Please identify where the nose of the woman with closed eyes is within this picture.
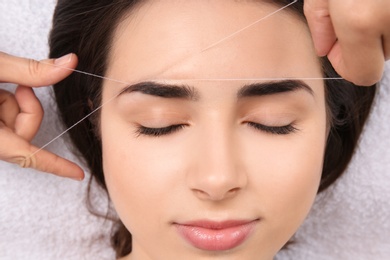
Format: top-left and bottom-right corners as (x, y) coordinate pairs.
(187, 128), (247, 201)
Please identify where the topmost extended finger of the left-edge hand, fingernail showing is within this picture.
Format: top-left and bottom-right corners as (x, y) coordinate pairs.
(0, 52), (77, 87)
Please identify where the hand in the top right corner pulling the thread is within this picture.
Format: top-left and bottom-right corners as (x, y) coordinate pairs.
(305, 0), (390, 86)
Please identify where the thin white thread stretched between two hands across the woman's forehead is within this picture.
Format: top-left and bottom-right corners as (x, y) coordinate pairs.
(30, 0), (343, 158)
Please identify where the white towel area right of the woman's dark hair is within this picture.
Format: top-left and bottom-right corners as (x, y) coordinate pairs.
(277, 62), (390, 260)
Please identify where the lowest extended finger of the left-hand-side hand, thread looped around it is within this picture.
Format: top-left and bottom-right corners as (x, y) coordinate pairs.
(0, 124), (84, 180)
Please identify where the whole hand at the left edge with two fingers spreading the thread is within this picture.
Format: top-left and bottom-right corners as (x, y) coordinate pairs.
(0, 52), (84, 180)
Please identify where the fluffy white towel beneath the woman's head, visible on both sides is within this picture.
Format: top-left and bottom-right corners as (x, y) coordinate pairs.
(0, 0), (390, 260)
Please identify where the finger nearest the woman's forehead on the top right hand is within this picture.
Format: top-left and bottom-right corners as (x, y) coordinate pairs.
(304, 0), (337, 56)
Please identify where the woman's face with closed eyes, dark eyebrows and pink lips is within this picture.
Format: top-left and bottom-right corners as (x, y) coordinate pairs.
(101, 0), (327, 260)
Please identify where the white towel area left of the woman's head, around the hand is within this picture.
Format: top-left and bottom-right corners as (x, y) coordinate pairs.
(0, 0), (115, 260)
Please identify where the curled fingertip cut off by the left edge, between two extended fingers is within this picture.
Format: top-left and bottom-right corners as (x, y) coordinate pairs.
(0, 89), (19, 129)
